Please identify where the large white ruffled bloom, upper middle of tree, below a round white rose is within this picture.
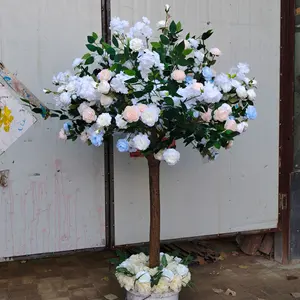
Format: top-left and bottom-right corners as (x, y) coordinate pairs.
(137, 49), (164, 81)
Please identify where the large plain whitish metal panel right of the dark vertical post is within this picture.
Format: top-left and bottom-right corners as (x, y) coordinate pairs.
(112, 0), (280, 245)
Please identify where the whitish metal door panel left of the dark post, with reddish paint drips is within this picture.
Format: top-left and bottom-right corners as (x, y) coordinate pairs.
(0, 0), (105, 257)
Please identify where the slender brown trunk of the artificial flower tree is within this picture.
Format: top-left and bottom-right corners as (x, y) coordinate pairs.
(147, 155), (160, 268)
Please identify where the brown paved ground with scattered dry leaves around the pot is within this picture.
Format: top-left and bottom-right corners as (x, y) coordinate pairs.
(0, 252), (300, 300)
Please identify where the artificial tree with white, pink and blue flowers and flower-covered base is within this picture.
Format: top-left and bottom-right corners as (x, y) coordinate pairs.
(26, 5), (257, 299)
